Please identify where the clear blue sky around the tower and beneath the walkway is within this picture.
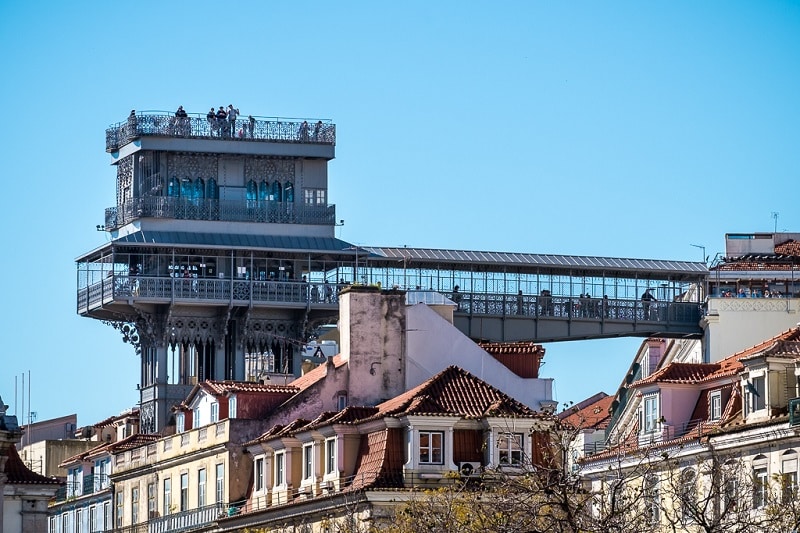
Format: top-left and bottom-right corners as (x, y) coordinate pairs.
(0, 0), (800, 424)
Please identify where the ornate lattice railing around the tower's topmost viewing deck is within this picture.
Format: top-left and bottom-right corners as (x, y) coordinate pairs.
(106, 112), (336, 152)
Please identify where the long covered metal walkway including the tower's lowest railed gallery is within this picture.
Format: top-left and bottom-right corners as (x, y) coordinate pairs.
(77, 239), (708, 342)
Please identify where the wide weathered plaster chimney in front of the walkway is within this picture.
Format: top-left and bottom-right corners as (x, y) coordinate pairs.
(339, 285), (406, 405)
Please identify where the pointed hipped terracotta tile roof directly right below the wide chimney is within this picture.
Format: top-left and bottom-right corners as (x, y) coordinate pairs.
(372, 366), (543, 418)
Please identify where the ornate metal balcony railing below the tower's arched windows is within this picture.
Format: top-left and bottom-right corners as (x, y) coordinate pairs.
(105, 196), (336, 230)
